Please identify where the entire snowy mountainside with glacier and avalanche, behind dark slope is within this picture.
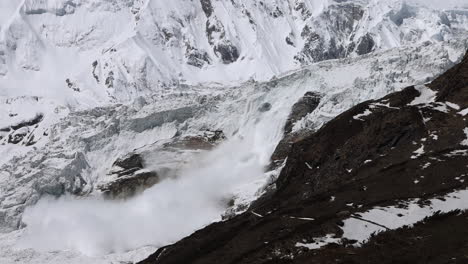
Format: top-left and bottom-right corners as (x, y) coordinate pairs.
(0, 0), (468, 263)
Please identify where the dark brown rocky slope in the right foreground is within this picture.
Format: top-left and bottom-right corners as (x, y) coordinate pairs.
(141, 50), (468, 264)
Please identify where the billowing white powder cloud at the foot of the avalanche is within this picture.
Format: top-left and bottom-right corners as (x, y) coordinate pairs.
(20, 136), (263, 256)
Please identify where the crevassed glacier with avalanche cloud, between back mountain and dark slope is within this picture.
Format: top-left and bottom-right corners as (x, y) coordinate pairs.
(0, 41), (464, 259)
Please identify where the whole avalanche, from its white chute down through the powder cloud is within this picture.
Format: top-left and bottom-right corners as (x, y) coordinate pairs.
(14, 64), (316, 256)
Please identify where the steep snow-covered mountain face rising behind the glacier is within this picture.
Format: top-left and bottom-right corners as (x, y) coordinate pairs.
(0, 0), (468, 103)
